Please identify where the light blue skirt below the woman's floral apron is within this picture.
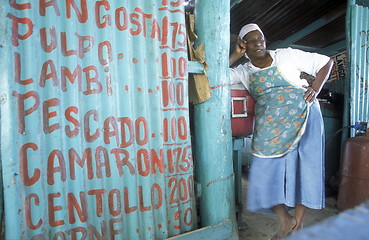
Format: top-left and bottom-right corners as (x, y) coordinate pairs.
(246, 100), (325, 213)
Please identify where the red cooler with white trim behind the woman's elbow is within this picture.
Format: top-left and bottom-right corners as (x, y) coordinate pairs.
(231, 84), (255, 137)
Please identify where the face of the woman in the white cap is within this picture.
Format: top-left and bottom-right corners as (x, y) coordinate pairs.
(243, 30), (267, 59)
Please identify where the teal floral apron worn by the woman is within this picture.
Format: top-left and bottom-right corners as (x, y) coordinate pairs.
(249, 67), (309, 158)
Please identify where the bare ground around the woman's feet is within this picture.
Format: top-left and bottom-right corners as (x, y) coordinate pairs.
(239, 172), (339, 240)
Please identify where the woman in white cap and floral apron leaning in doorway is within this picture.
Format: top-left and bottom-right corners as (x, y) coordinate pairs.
(230, 24), (333, 239)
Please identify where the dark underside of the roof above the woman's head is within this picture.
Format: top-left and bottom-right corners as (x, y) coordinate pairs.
(231, 0), (346, 52)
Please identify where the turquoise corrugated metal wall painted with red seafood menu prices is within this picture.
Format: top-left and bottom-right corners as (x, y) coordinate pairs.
(0, 0), (197, 239)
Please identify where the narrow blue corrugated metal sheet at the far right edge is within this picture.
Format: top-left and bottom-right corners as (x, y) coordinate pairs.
(349, 1), (369, 136)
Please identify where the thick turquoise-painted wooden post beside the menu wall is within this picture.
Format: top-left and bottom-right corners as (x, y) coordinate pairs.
(194, 0), (237, 239)
